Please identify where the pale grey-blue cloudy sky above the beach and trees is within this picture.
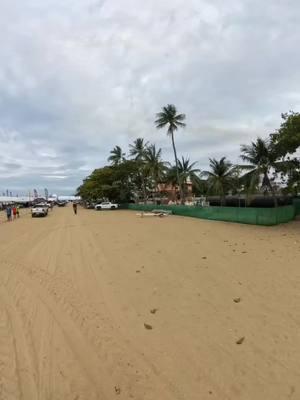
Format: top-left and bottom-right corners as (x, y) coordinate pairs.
(0, 0), (300, 194)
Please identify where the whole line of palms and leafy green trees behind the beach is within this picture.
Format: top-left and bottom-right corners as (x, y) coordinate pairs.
(77, 105), (300, 206)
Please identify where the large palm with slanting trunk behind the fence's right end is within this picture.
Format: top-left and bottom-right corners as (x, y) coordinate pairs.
(240, 138), (278, 207)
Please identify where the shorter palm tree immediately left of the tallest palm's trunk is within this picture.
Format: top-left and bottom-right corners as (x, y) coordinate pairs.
(144, 144), (167, 197)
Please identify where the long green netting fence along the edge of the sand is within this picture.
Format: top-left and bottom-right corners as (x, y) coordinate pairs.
(128, 201), (300, 226)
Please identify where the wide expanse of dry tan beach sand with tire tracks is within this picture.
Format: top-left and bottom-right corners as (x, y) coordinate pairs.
(0, 207), (300, 400)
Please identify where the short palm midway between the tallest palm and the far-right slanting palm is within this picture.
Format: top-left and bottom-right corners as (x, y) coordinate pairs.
(202, 157), (235, 205)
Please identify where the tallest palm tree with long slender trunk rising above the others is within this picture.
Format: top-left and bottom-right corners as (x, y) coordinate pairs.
(155, 104), (186, 201)
